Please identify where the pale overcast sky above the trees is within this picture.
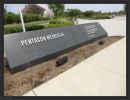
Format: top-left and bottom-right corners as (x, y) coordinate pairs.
(5, 4), (124, 13)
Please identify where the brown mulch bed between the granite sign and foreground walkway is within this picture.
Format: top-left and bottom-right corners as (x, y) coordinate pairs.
(4, 36), (123, 96)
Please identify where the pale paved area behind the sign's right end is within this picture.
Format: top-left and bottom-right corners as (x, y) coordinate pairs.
(78, 16), (126, 36)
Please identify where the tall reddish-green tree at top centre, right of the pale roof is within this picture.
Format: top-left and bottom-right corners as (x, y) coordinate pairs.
(48, 4), (65, 16)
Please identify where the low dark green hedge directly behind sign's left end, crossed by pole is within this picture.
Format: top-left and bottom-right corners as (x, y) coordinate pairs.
(4, 24), (45, 34)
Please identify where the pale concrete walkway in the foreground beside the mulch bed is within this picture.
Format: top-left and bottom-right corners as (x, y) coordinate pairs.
(24, 38), (126, 96)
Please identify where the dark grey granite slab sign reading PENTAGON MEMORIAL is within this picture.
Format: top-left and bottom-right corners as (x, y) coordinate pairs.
(4, 22), (107, 73)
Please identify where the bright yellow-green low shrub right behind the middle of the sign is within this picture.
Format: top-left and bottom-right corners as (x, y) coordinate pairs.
(48, 19), (73, 28)
